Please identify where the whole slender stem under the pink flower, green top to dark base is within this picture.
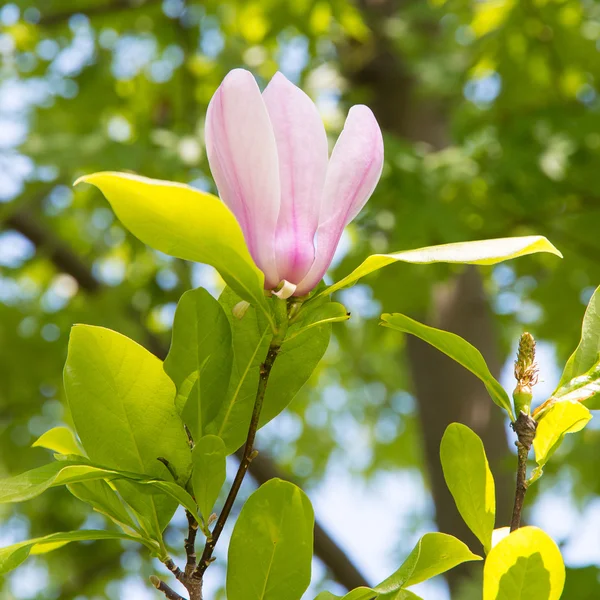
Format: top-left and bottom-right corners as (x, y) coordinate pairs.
(193, 296), (288, 580)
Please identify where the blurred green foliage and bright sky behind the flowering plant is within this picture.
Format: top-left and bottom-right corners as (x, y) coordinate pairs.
(0, 0), (600, 600)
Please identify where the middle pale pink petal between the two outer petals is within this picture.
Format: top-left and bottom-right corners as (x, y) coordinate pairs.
(263, 73), (328, 283)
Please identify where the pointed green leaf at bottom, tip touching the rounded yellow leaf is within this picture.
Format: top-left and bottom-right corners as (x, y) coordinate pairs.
(375, 532), (481, 597)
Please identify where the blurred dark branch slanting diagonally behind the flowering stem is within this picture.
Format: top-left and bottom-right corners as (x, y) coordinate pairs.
(0, 211), (369, 590)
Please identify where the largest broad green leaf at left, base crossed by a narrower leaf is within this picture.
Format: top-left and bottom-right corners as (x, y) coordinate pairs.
(64, 325), (191, 537)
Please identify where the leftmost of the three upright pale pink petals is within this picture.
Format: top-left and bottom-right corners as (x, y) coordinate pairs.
(205, 69), (281, 288)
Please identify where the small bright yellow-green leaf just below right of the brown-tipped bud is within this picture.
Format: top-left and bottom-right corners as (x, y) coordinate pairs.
(530, 402), (592, 483)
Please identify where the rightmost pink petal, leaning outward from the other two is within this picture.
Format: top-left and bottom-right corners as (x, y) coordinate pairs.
(296, 105), (383, 296)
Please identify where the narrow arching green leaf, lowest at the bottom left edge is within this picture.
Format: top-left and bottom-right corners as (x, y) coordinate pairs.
(0, 529), (157, 575)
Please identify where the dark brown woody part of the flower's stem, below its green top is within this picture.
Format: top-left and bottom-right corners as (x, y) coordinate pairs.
(194, 336), (287, 579)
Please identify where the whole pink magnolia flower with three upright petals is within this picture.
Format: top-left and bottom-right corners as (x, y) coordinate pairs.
(206, 69), (383, 296)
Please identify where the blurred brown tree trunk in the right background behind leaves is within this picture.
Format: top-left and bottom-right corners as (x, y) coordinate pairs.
(341, 0), (514, 590)
